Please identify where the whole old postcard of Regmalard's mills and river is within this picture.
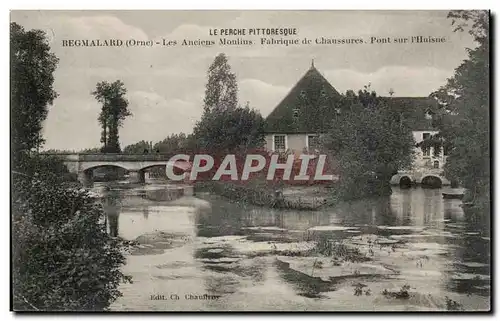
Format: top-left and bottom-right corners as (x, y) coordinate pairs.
(10, 10), (492, 312)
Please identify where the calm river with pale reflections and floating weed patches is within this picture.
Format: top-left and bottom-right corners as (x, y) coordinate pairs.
(95, 187), (490, 311)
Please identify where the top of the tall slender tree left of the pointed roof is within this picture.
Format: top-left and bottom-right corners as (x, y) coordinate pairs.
(204, 53), (238, 112)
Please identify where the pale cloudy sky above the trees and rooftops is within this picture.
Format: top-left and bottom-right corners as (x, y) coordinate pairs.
(11, 11), (474, 150)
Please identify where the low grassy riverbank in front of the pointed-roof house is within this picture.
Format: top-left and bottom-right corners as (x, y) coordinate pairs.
(195, 181), (331, 211)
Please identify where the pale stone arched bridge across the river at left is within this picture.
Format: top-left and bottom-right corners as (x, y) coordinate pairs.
(48, 154), (189, 186)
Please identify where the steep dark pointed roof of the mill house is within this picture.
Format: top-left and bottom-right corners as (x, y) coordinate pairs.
(266, 63), (341, 133)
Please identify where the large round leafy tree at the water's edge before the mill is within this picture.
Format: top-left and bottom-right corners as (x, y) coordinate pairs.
(324, 86), (415, 199)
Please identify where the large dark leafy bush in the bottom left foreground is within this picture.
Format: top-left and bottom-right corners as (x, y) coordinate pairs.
(12, 173), (131, 311)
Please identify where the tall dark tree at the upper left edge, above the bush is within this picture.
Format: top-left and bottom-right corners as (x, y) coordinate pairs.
(10, 22), (59, 168)
